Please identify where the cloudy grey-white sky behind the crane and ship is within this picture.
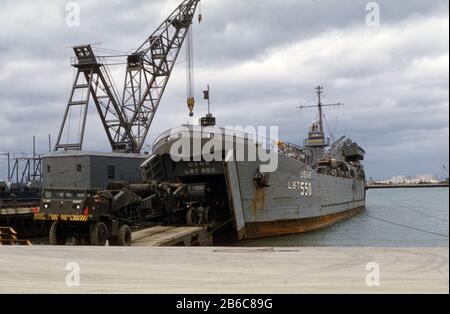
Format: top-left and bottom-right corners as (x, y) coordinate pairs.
(0, 0), (449, 179)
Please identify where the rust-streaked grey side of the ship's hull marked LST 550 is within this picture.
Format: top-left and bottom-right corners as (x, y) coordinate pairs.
(235, 155), (365, 239)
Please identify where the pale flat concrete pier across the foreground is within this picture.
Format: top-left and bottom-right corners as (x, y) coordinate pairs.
(0, 246), (449, 293)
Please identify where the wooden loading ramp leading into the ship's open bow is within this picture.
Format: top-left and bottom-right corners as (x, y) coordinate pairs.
(131, 226), (212, 246)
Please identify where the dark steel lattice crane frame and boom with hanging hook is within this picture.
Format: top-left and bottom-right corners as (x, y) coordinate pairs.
(55, 0), (201, 153)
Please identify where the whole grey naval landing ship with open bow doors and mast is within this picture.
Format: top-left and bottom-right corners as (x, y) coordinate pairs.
(142, 87), (365, 239)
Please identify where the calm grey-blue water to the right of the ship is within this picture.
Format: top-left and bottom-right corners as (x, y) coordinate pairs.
(235, 188), (449, 247)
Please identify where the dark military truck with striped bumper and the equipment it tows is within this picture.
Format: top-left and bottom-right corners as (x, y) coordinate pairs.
(35, 181), (210, 246)
